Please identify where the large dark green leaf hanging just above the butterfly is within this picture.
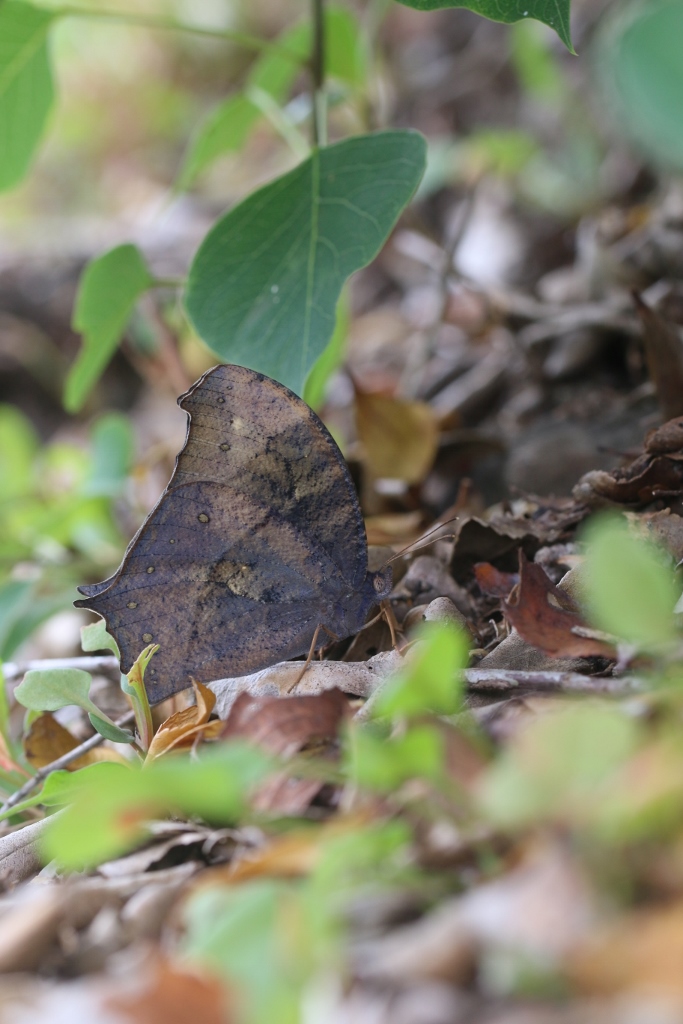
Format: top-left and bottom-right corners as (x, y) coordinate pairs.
(185, 131), (425, 394)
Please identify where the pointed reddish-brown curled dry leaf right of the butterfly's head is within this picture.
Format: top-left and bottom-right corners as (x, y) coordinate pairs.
(503, 552), (614, 657)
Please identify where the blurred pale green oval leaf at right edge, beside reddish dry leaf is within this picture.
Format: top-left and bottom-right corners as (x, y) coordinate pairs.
(584, 515), (679, 649)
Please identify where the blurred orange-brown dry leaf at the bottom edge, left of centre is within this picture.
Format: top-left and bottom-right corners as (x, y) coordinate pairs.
(103, 961), (230, 1024)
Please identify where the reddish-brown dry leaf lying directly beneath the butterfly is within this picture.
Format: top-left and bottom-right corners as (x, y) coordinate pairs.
(221, 688), (348, 758)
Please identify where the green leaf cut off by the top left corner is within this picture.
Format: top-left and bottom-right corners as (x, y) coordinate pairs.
(0, 0), (56, 189)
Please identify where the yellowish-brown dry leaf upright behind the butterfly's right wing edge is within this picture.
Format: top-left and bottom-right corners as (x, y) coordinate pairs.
(355, 391), (438, 483)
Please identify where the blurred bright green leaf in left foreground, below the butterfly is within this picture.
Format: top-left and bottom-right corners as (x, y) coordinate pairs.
(43, 742), (272, 870)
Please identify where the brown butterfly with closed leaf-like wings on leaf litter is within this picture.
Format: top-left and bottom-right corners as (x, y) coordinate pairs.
(75, 366), (391, 703)
